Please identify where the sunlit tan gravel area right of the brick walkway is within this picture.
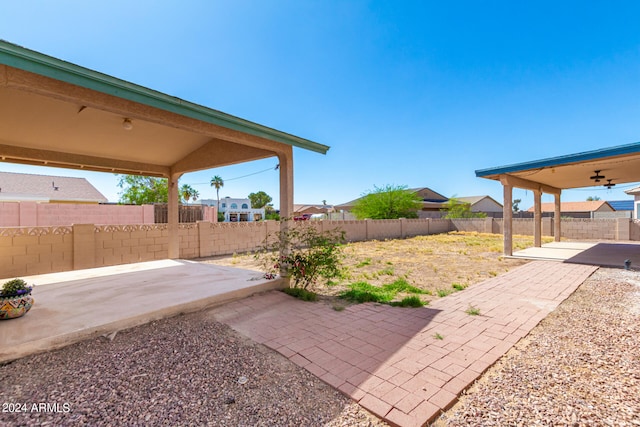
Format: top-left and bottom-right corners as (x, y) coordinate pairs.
(436, 269), (640, 426)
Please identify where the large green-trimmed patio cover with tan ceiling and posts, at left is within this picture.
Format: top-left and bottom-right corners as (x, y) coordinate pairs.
(0, 40), (329, 258)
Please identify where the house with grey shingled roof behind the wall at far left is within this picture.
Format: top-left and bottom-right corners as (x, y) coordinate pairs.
(0, 172), (108, 204)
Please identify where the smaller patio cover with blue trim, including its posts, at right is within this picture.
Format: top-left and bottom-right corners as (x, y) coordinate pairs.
(476, 142), (640, 255)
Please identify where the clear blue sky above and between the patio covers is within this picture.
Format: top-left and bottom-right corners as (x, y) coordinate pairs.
(0, 0), (640, 209)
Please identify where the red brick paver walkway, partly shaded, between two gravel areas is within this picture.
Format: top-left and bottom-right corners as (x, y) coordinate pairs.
(215, 261), (597, 426)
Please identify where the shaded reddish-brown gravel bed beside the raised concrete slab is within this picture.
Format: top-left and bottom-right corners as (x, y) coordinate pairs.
(0, 312), (384, 427)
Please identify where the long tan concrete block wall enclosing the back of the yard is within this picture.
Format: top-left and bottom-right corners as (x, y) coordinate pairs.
(0, 218), (640, 279)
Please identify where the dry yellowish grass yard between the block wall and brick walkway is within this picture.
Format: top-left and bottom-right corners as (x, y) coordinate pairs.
(204, 232), (551, 302)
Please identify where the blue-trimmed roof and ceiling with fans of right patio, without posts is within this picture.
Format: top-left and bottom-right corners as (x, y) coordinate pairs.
(476, 142), (640, 189)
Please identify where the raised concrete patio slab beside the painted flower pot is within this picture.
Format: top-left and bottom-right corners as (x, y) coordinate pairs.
(0, 260), (282, 362)
